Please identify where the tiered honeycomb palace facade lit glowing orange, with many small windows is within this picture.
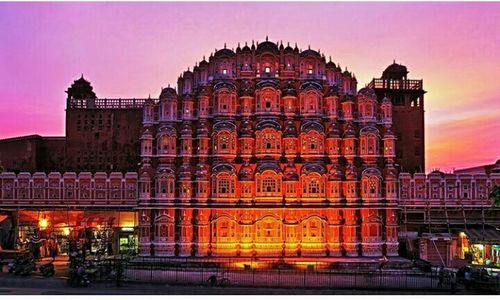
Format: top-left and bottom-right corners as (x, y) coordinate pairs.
(138, 40), (398, 257)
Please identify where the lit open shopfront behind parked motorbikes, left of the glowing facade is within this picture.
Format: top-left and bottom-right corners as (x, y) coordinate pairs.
(15, 210), (137, 256)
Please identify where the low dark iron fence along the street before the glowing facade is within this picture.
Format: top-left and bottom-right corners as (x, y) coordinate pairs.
(96, 259), (455, 291)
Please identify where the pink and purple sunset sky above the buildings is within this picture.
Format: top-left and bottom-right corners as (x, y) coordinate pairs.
(0, 2), (500, 171)
